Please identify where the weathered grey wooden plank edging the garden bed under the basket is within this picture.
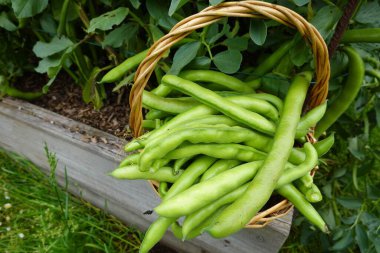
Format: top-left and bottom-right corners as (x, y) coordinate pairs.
(0, 99), (292, 253)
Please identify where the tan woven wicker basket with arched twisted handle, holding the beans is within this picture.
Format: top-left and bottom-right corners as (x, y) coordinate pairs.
(129, 1), (330, 228)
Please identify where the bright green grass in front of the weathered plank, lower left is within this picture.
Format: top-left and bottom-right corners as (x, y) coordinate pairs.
(0, 149), (143, 253)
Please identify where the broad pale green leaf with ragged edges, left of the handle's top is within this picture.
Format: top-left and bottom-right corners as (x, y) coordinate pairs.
(87, 7), (129, 33)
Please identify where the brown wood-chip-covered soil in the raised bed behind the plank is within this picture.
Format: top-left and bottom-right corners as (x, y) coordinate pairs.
(18, 71), (131, 139)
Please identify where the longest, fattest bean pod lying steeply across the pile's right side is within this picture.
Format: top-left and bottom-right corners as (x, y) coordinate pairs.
(208, 72), (311, 238)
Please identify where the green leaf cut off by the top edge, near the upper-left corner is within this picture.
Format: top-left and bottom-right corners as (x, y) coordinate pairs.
(12, 0), (48, 18)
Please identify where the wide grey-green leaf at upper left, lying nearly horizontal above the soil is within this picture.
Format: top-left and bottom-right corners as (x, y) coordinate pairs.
(33, 36), (74, 58)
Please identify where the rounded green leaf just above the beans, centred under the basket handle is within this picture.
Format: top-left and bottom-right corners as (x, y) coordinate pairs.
(213, 50), (243, 74)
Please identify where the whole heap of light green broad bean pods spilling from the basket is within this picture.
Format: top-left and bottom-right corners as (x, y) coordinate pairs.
(111, 70), (334, 252)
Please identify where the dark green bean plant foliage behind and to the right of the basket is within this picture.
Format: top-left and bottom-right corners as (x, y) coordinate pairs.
(0, 0), (380, 252)
